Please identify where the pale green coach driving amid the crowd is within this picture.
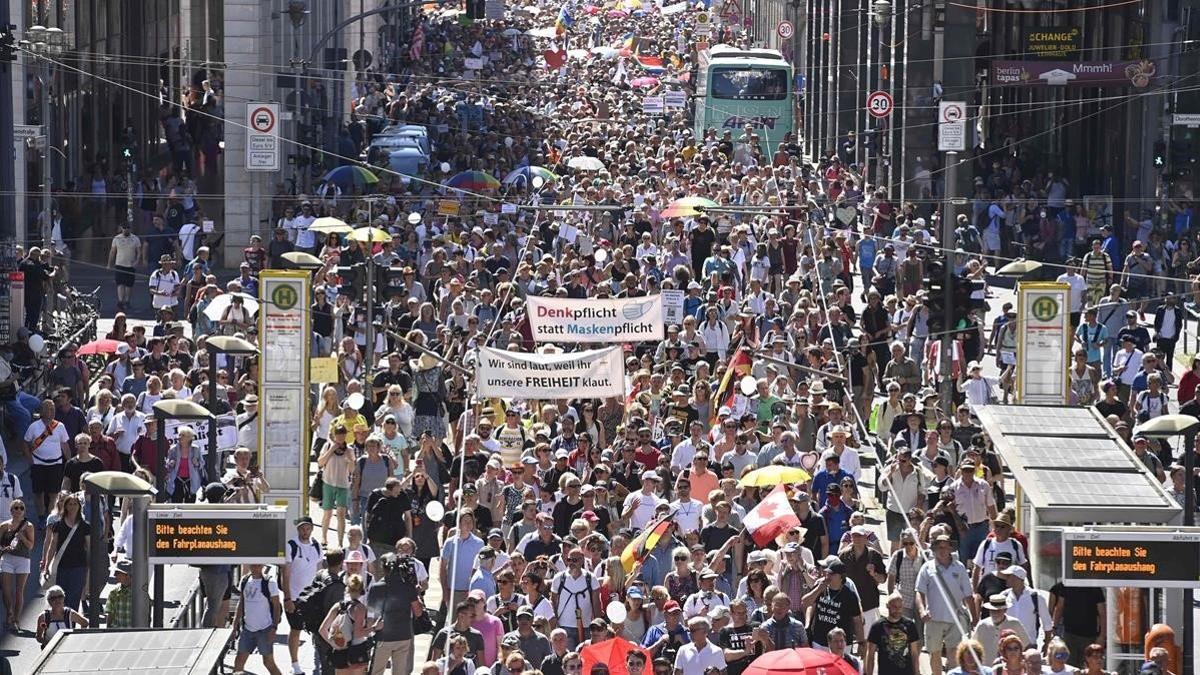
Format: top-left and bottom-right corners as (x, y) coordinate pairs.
(695, 44), (794, 157)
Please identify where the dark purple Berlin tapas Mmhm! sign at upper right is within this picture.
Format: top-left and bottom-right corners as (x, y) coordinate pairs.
(991, 60), (1157, 88)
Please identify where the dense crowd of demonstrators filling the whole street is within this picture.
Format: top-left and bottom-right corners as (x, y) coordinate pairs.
(7, 2), (1200, 675)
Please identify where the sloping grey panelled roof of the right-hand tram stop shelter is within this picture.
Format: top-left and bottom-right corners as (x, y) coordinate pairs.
(978, 406), (1183, 525)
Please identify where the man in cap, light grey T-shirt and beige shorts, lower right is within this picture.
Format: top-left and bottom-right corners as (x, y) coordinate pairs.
(917, 534), (979, 675)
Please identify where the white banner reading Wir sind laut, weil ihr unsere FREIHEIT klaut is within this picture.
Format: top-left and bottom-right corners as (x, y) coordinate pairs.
(475, 347), (625, 400)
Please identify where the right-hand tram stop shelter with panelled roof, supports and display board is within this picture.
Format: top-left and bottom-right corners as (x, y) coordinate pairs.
(977, 405), (1200, 673)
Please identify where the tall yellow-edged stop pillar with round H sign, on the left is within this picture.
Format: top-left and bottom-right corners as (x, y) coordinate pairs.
(258, 270), (312, 519)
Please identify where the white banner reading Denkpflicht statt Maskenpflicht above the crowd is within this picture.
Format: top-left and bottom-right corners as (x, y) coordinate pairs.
(528, 295), (664, 342)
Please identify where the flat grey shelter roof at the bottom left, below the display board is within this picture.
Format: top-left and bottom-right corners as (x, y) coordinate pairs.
(30, 628), (233, 675)
